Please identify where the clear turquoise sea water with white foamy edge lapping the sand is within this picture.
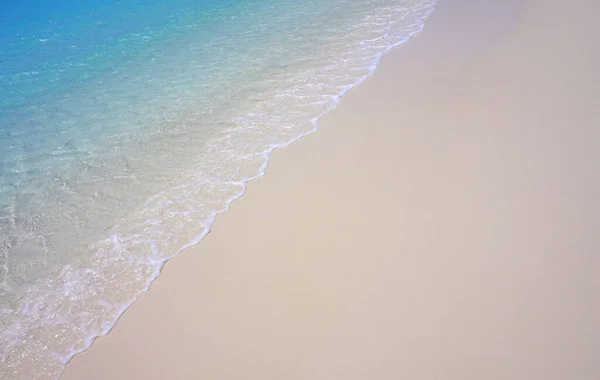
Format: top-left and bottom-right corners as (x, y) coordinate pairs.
(0, 0), (435, 379)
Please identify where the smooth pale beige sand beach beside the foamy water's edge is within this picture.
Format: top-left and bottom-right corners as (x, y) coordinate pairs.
(64, 0), (600, 380)
